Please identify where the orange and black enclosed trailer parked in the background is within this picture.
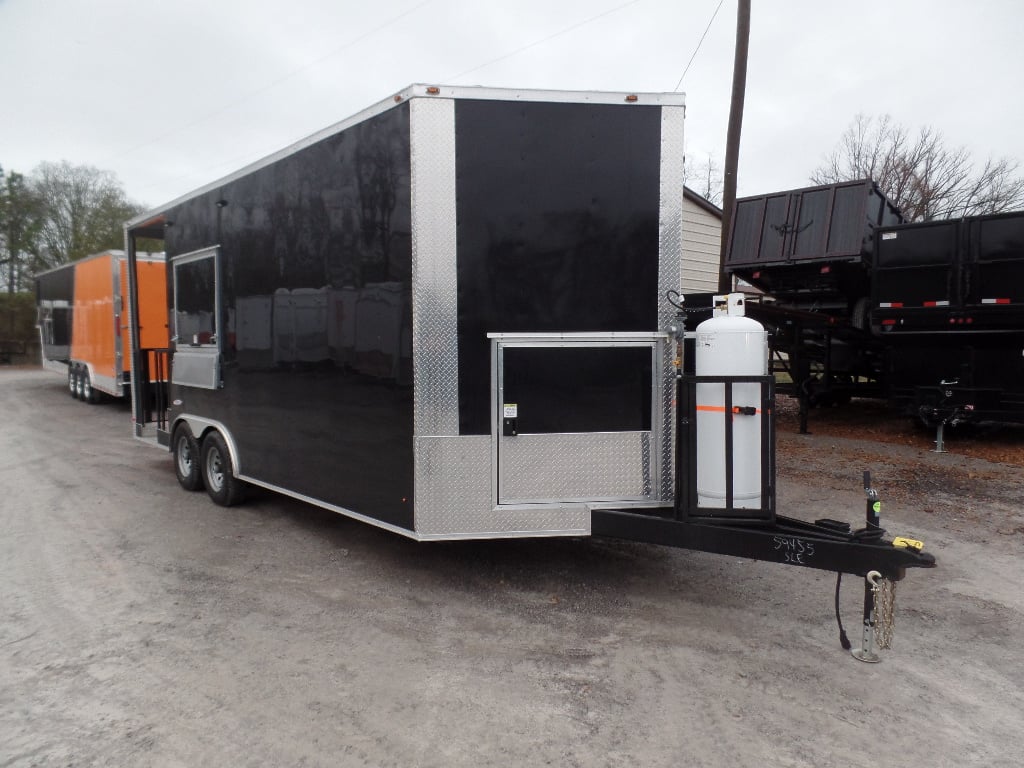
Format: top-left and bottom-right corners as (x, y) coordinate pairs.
(36, 250), (168, 403)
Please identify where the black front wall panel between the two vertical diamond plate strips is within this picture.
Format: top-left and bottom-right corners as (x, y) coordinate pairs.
(455, 99), (662, 434)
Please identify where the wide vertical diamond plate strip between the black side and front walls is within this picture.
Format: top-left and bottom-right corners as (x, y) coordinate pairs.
(410, 98), (459, 438)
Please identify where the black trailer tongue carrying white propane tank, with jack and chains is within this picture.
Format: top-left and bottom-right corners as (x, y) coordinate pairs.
(591, 294), (936, 662)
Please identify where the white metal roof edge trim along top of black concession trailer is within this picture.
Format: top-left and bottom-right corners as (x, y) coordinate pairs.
(125, 83), (686, 230)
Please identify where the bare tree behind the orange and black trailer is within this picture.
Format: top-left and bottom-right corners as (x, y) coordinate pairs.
(32, 161), (142, 267)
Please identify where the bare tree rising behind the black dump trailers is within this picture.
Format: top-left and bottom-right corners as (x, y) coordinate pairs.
(811, 115), (1024, 221)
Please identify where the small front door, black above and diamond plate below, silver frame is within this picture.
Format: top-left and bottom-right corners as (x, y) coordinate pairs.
(493, 334), (662, 505)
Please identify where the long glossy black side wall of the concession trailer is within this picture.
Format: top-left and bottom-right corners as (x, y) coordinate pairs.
(165, 103), (413, 529)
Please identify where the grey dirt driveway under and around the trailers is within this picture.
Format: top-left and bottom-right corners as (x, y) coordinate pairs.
(0, 369), (1024, 768)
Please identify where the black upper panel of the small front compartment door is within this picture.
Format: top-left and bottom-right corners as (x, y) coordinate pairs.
(502, 347), (651, 434)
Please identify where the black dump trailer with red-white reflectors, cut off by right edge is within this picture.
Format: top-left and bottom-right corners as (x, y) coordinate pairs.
(870, 212), (1024, 424)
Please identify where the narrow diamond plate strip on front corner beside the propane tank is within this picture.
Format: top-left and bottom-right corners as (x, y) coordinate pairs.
(657, 106), (686, 501)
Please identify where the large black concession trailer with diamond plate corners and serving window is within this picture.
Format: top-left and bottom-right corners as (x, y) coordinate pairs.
(126, 90), (934, 655)
